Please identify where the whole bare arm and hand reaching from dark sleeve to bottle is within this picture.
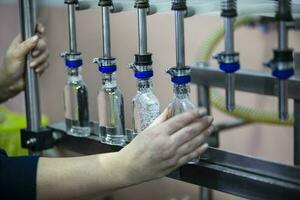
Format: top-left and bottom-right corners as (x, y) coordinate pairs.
(37, 110), (213, 200)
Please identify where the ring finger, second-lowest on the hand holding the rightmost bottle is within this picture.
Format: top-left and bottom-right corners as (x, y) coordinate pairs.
(176, 126), (213, 157)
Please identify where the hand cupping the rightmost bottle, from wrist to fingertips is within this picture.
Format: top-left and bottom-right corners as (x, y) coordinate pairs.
(119, 109), (213, 184)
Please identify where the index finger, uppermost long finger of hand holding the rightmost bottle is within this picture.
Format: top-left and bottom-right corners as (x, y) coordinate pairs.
(163, 109), (207, 135)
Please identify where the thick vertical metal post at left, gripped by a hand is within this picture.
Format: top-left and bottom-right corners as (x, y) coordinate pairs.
(19, 0), (41, 132)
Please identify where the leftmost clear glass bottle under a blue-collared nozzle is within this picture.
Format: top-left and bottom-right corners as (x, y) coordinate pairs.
(64, 68), (91, 137)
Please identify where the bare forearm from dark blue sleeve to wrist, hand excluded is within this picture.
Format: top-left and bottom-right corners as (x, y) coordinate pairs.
(37, 153), (135, 200)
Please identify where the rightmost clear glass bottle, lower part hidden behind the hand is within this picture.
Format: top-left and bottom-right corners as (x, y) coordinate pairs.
(168, 84), (196, 119)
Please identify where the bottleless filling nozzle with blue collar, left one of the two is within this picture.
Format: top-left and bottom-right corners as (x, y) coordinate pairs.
(215, 0), (240, 112)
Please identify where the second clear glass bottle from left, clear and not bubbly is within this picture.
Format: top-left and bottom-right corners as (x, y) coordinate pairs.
(98, 73), (127, 146)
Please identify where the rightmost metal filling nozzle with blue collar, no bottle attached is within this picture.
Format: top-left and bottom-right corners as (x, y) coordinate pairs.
(268, 0), (294, 120)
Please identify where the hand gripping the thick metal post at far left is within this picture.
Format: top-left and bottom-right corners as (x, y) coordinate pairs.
(0, 24), (49, 95)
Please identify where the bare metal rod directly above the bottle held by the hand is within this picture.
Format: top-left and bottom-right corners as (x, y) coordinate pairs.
(175, 10), (185, 69)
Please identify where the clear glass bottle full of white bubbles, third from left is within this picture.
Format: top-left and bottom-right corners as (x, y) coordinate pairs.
(132, 78), (160, 134)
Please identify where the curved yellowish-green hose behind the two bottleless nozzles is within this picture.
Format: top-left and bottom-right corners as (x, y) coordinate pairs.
(198, 17), (294, 126)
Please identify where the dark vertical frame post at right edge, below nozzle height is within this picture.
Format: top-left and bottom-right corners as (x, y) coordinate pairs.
(294, 100), (300, 165)
